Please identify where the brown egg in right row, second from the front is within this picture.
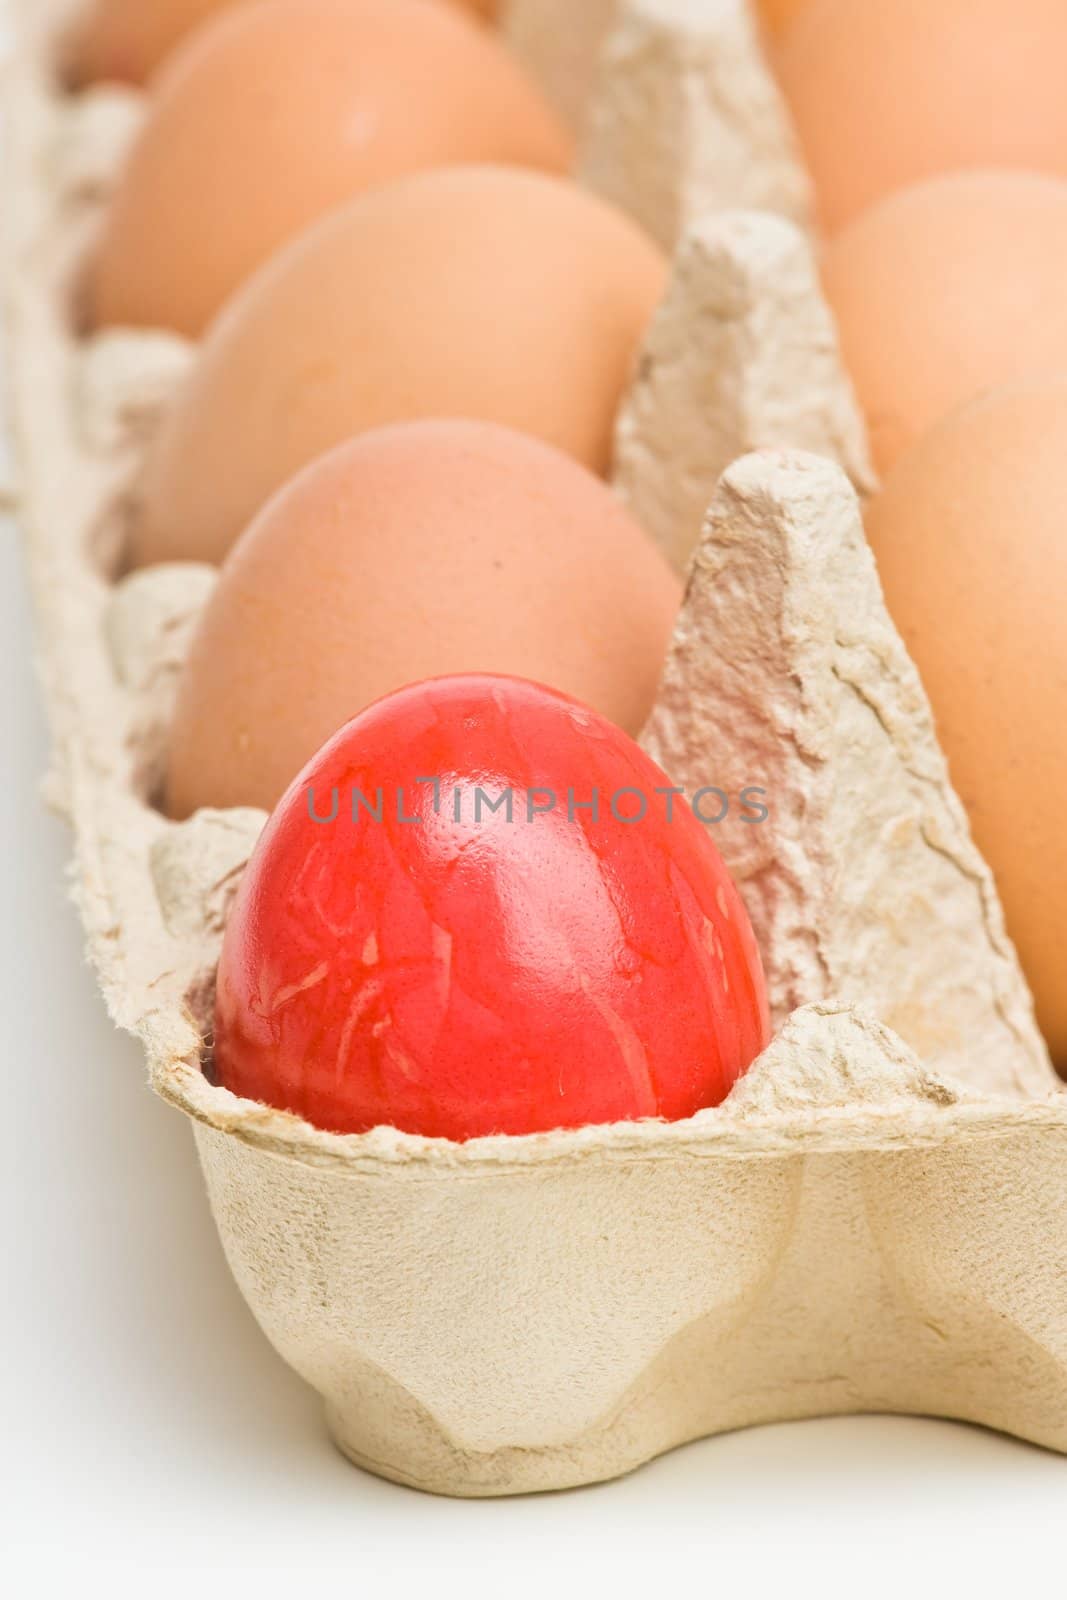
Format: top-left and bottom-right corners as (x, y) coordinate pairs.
(822, 171), (1067, 472)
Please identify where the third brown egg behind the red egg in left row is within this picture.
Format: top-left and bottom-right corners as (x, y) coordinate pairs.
(88, 0), (573, 336)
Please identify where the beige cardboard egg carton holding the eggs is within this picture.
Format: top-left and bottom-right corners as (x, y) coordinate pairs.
(5, 0), (1067, 1496)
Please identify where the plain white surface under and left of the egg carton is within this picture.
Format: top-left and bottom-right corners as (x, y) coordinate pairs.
(0, 525), (1067, 1600)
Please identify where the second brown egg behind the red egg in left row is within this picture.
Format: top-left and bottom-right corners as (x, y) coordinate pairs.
(133, 168), (667, 565)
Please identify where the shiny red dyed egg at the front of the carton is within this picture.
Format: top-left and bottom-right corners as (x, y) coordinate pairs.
(214, 675), (768, 1139)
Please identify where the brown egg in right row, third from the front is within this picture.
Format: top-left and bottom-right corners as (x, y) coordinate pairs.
(777, 0), (1067, 230)
